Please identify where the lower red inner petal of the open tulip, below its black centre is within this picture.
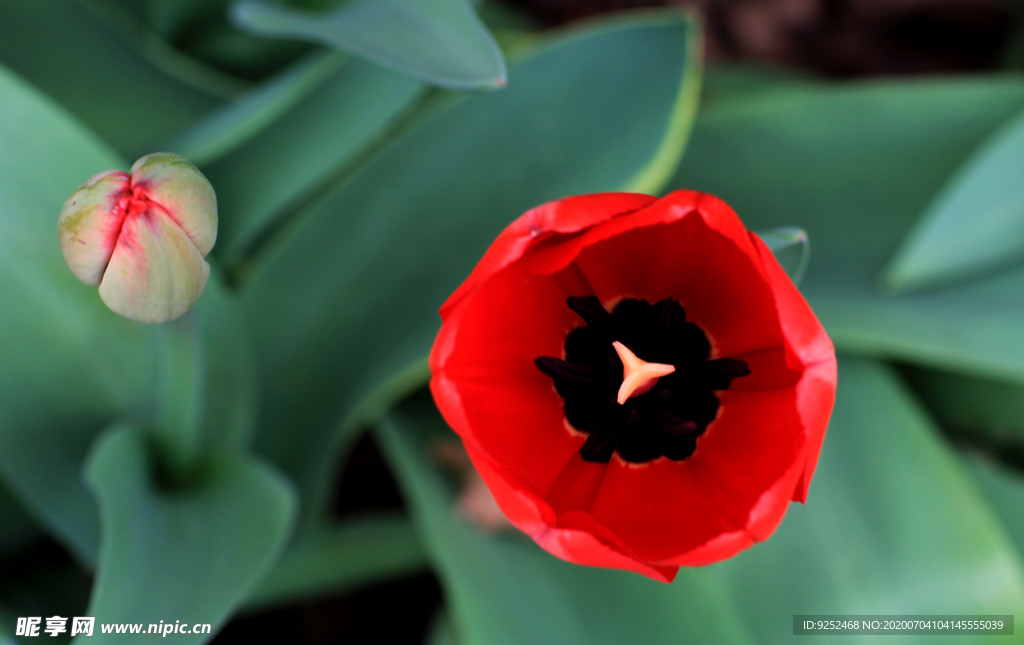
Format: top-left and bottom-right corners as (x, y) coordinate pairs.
(577, 388), (805, 563)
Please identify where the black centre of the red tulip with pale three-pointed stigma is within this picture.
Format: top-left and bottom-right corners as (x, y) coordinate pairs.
(535, 296), (751, 464)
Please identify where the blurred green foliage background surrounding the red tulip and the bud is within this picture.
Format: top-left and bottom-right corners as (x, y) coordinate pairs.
(0, 0), (1024, 645)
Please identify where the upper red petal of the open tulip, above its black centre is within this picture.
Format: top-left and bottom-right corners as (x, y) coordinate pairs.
(526, 190), (785, 364)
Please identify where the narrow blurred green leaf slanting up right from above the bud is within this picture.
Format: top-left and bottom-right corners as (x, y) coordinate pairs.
(160, 52), (345, 166)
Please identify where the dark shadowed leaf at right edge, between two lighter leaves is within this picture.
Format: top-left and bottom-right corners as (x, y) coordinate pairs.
(905, 368), (1024, 447)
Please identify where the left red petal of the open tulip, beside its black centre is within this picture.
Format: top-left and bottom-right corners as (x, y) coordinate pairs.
(431, 263), (586, 496)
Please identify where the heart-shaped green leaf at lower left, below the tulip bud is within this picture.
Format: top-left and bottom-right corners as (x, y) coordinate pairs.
(76, 427), (296, 644)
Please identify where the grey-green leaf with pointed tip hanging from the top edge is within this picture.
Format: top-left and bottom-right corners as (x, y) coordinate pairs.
(230, 0), (505, 89)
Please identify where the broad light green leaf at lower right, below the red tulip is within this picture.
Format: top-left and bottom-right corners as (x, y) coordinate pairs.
(708, 356), (1024, 643)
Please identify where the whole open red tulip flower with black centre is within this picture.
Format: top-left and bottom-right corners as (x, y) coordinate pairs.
(430, 190), (836, 582)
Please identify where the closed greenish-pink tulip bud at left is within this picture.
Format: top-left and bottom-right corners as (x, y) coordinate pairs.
(57, 153), (217, 323)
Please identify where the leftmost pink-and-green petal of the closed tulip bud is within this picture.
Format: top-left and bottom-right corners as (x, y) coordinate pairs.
(57, 170), (129, 287)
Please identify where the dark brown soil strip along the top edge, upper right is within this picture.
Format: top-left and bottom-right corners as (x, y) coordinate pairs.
(513, 0), (1022, 76)
